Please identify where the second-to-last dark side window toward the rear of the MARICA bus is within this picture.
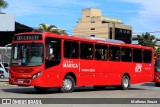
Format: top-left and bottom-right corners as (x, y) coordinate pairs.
(133, 49), (142, 62)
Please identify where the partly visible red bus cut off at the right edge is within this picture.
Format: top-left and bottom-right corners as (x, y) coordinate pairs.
(154, 54), (160, 87)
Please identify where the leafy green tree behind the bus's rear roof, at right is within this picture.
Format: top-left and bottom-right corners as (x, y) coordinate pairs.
(138, 32), (156, 48)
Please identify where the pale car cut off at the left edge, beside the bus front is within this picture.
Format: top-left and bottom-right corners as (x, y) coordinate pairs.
(0, 62), (9, 79)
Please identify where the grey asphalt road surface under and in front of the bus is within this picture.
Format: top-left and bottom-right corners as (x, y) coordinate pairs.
(0, 82), (160, 107)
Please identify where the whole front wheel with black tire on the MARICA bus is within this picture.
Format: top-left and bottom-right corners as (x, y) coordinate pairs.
(59, 75), (75, 93)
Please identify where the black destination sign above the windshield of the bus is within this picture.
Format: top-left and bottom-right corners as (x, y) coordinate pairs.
(14, 34), (42, 40)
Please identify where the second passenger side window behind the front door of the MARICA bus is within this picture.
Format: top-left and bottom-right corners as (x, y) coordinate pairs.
(80, 43), (93, 59)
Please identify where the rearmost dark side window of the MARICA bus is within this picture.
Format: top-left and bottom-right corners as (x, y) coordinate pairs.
(143, 50), (152, 63)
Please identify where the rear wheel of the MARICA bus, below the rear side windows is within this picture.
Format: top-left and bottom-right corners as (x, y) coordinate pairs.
(116, 75), (130, 90)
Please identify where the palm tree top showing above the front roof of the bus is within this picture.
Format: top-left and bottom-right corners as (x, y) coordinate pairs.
(34, 23), (68, 35)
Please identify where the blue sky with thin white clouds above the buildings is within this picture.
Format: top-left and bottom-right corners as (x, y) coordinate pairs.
(2, 0), (160, 36)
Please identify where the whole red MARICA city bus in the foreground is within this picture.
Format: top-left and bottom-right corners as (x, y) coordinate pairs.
(9, 32), (154, 92)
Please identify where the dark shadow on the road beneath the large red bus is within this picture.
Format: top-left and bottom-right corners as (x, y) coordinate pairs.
(2, 87), (145, 95)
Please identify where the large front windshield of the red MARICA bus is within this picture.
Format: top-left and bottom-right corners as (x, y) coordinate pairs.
(11, 43), (44, 66)
